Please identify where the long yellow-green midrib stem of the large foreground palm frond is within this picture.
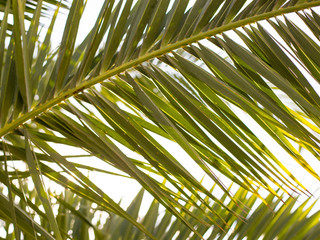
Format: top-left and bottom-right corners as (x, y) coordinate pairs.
(0, 0), (320, 137)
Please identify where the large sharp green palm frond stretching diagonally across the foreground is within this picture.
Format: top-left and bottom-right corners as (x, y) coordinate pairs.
(0, 0), (320, 237)
